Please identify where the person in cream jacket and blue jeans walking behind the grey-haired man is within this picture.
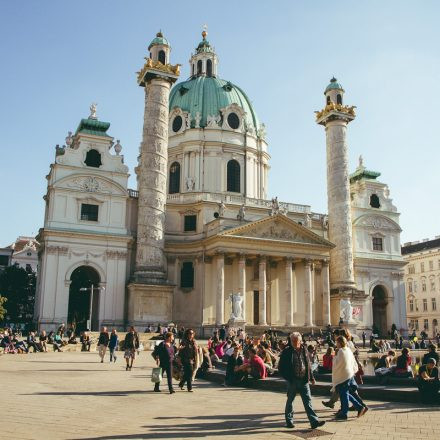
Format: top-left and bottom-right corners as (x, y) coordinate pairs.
(332, 336), (368, 420)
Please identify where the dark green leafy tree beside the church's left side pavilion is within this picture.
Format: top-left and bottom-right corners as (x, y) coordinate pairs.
(0, 265), (37, 324)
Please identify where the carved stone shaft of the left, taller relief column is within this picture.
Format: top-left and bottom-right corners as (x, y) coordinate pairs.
(135, 77), (170, 281)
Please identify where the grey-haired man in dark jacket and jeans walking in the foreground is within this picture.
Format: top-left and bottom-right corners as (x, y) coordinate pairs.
(278, 332), (325, 429)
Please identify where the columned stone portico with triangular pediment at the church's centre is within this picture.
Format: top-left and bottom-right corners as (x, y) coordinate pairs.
(165, 214), (333, 334)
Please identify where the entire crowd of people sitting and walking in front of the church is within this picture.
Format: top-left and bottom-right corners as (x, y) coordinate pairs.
(0, 324), (440, 416)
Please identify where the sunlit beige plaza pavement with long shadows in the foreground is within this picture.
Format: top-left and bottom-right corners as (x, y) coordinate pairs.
(0, 352), (440, 440)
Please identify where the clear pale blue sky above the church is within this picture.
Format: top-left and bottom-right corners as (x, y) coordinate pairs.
(0, 0), (440, 247)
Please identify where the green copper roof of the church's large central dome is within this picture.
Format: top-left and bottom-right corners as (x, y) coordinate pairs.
(170, 76), (261, 132)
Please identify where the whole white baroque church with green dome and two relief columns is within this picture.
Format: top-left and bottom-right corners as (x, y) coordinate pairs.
(35, 32), (406, 335)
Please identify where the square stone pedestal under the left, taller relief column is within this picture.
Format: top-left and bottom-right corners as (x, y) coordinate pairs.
(127, 282), (174, 327)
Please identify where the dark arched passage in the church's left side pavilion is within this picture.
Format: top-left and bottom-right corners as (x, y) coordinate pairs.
(67, 266), (101, 333)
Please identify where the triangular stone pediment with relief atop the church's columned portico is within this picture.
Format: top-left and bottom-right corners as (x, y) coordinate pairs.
(220, 214), (334, 247)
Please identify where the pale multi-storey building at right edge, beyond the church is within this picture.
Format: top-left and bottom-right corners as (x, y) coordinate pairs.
(402, 236), (440, 337)
